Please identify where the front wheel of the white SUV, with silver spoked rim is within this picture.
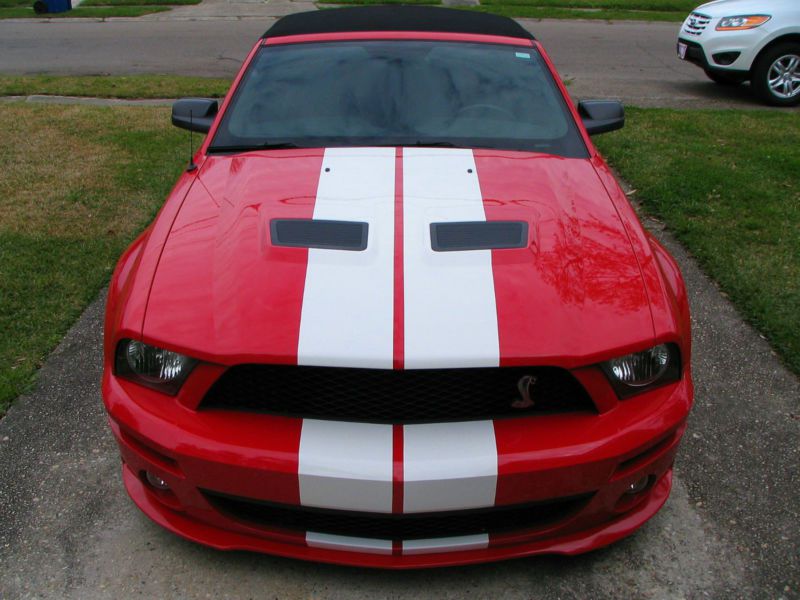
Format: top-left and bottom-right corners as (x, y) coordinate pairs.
(751, 43), (800, 106)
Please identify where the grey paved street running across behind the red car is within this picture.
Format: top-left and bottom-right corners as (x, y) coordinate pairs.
(0, 15), (776, 108)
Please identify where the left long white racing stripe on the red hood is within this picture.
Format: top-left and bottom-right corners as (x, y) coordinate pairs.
(297, 148), (395, 369)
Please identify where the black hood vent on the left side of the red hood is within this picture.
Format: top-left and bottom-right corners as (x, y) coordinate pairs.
(270, 219), (369, 251)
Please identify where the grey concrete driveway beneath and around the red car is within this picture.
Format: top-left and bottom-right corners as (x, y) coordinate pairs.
(0, 204), (800, 600)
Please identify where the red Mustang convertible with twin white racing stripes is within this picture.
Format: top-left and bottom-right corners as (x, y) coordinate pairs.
(103, 7), (692, 567)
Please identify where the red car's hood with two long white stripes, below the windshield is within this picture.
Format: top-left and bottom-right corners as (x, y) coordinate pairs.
(143, 148), (654, 368)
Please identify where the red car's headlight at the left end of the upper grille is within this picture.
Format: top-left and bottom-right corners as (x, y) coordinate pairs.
(114, 339), (197, 396)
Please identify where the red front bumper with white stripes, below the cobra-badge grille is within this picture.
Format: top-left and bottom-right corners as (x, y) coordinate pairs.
(103, 373), (692, 568)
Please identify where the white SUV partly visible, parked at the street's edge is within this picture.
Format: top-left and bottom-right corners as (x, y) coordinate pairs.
(678, 0), (800, 106)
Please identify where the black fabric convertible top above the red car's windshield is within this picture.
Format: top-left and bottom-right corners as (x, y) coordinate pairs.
(263, 6), (534, 39)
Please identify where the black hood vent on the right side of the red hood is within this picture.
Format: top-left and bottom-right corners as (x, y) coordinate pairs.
(431, 221), (528, 252)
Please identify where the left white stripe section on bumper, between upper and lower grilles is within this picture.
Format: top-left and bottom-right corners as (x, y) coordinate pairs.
(298, 419), (392, 513)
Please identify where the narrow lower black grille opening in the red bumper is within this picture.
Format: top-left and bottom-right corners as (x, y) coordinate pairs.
(203, 491), (592, 541)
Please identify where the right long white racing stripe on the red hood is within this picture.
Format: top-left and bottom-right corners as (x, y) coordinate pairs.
(403, 148), (500, 369)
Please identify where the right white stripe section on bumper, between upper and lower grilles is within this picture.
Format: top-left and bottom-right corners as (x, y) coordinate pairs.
(403, 421), (497, 513)
